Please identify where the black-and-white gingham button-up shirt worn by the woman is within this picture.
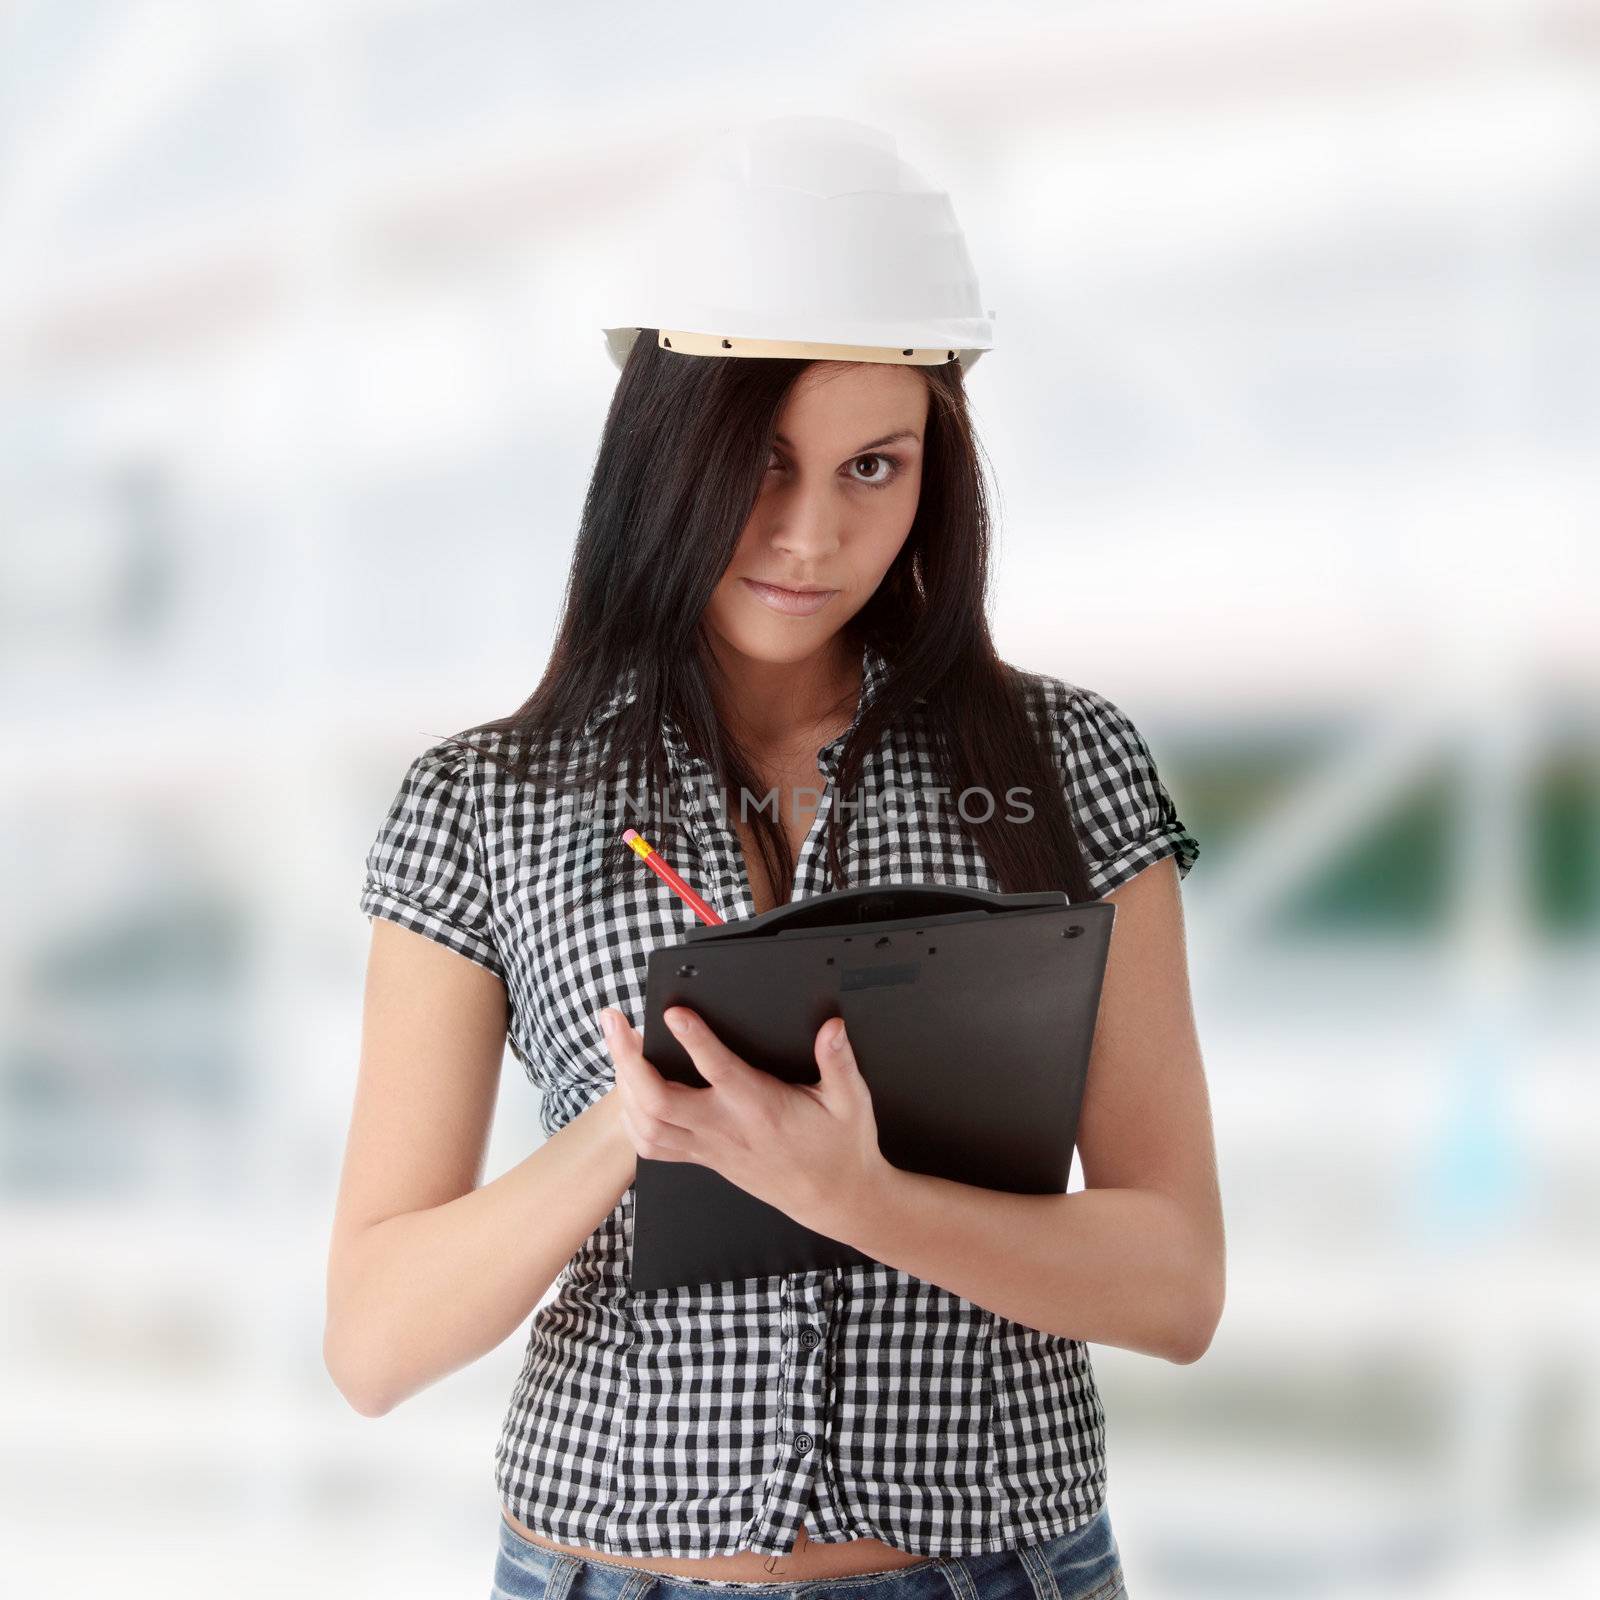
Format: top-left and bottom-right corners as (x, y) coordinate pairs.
(360, 650), (1198, 1557)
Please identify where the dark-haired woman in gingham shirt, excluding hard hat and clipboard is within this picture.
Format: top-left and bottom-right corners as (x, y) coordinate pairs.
(325, 121), (1222, 1600)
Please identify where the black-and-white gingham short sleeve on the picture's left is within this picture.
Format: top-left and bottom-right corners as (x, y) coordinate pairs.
(362, 744), (506, 981)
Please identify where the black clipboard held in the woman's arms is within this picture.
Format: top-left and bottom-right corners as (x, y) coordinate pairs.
(629, 883), (1117, 1293)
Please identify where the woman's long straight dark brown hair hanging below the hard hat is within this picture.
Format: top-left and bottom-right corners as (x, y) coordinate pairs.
(458, 328), (1093, 901)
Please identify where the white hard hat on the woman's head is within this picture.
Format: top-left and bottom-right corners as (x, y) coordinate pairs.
(605, 117), (994, 370)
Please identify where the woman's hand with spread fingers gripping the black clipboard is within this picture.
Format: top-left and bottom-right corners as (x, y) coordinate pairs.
(600, 1005), (888, 1238)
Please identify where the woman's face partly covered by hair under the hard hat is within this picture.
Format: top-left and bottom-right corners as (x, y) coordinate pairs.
(706, 362), (928, 664)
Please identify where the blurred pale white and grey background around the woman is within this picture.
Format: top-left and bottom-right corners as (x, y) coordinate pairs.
(0, 0), (1600, 1600)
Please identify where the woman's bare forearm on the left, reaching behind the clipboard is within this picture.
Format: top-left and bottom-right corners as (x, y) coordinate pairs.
(325, 1090), (637, 1416)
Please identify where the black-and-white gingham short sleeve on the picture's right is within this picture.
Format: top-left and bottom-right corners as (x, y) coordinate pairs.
(1059, 686), (1200, 896)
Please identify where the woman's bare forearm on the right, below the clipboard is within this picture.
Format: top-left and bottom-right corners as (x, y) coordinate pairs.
(826, 1165), (1222, 1362)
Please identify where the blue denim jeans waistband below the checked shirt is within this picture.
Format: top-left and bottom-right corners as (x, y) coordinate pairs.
(491, 1506), (1128, 1600)
